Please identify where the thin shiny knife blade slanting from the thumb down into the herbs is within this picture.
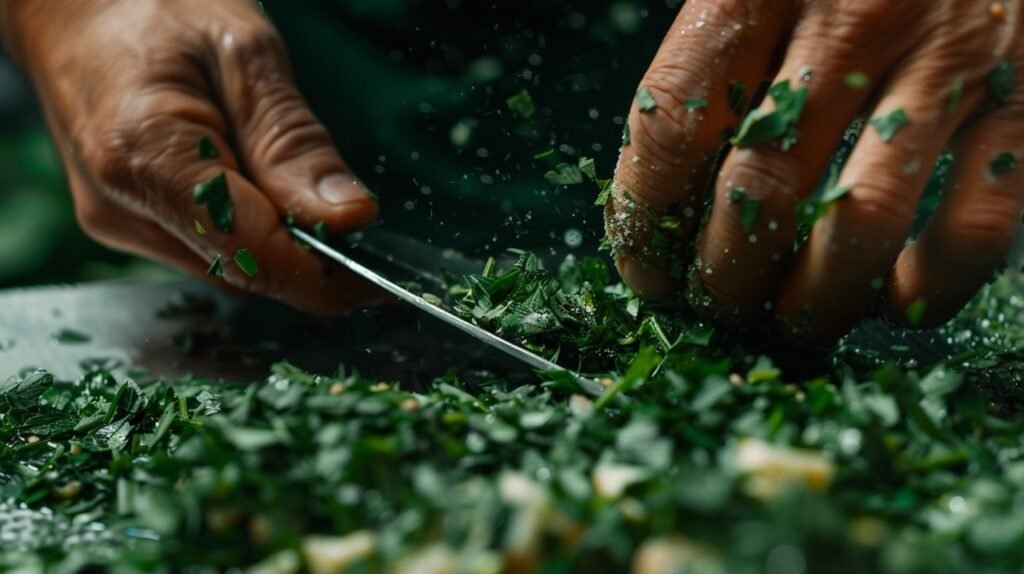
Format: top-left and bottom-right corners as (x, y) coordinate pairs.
(292, 228), (581, 380)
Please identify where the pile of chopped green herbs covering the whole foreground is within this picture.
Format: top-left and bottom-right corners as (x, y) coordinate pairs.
(6, 253), (1024, 573)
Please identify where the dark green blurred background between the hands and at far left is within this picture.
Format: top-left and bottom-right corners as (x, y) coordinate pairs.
(0, 0), (681, 286)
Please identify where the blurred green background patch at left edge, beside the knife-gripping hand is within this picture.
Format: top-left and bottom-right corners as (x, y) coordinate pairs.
(0, 47), (177, 289)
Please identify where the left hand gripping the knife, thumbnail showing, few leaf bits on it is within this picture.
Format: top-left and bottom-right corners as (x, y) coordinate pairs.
(0, 0), (377, 312)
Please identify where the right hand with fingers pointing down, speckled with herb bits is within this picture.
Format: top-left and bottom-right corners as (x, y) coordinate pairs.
(606, 0), (1024, 343)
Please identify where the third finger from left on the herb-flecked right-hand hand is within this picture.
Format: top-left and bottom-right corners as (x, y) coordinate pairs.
(777, 69), (974, 341)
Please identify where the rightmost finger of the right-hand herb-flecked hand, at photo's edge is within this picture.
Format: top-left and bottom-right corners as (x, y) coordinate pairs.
(884, 90), (1024, 327)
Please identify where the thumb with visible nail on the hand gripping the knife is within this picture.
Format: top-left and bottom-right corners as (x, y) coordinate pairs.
(209, 7), (378, 233)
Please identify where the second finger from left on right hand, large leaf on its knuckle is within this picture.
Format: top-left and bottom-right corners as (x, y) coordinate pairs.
(691, 3), (918, 326)
